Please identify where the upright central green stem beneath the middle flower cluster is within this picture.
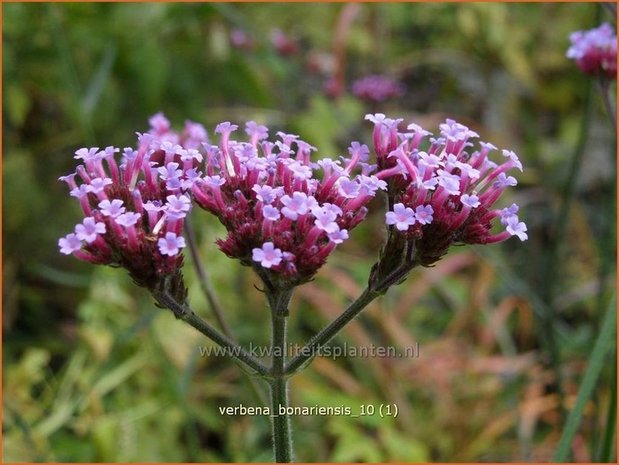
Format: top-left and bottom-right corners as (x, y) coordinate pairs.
(268, 291), (293, 463)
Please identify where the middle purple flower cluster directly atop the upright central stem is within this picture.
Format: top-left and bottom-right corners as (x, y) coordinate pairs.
(193, 121), (387, 286)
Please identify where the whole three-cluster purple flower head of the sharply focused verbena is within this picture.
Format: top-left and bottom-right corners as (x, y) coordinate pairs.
(59, 114), (527, 288)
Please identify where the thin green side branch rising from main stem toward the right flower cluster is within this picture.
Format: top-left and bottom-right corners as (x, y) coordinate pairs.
(285, 288), (381, 375)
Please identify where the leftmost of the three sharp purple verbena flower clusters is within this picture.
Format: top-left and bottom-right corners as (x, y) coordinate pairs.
(58, 114), (208, 288)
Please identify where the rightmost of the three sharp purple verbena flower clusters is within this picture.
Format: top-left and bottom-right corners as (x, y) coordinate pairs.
(366, 113), (527, 265)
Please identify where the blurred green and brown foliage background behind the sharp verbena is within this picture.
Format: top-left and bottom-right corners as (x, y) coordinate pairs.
(2, 3), (616, 462)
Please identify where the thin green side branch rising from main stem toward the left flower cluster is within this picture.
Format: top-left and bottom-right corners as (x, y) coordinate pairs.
(153, 291), (270, 378)
